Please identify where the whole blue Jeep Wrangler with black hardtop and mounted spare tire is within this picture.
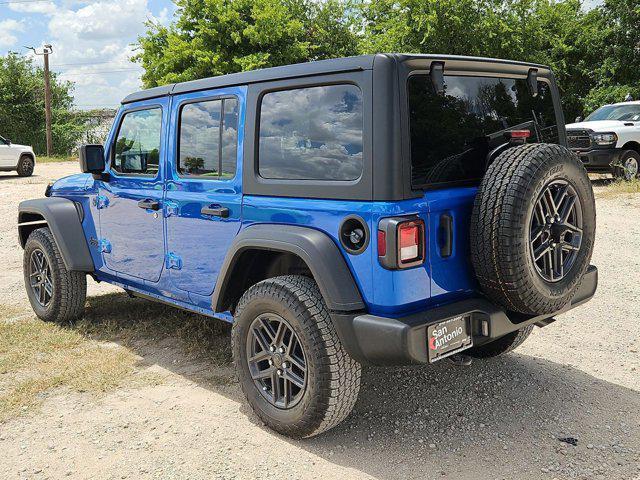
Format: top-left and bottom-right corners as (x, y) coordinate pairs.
(18, 54), (597, 437)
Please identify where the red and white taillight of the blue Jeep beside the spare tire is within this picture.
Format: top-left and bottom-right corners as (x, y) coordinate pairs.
(378, 217), (426, 270)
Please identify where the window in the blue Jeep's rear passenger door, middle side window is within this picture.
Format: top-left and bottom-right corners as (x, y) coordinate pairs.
(177, 98), (238, 179)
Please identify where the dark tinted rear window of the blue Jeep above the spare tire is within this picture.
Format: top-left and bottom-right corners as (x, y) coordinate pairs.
(408, 75), (558, 188)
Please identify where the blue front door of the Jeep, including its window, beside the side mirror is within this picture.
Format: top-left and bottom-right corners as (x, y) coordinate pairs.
(96, 98), (168, 282)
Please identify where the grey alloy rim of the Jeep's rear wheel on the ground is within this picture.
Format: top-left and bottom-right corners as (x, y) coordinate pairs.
(246, 313), (307, 409)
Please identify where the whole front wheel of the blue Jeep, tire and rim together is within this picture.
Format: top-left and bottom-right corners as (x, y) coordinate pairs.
(23, 228), (87, 323)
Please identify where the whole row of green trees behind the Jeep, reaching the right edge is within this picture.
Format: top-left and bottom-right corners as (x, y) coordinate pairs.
(135, 0), (640, 120)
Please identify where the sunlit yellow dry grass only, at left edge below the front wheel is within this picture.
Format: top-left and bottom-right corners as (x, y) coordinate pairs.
(0, 316), (137, 422)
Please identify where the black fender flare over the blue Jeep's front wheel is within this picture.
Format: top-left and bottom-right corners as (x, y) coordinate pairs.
(18, 197), (95, 272)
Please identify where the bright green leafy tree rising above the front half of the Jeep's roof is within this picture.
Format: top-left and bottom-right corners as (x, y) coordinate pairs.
(134, 0), (358, 87)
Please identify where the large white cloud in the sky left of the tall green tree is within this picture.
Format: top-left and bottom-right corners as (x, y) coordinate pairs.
(17, 0), (165, 109)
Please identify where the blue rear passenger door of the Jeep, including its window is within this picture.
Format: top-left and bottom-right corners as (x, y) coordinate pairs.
(165, 88), (245, 296)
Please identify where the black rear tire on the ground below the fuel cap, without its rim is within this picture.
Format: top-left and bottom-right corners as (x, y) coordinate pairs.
(231, 275), (361, 438)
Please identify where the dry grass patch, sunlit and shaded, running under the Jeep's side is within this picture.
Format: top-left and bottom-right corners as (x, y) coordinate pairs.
(0, 294), (231, 423)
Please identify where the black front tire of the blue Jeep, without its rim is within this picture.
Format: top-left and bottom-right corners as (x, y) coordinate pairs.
(23, 228), (87, 323)
